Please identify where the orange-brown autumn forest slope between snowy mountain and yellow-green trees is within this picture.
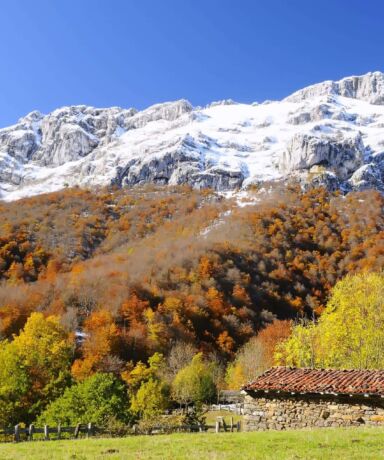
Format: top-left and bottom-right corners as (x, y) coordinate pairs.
(0, 186), (384, 356)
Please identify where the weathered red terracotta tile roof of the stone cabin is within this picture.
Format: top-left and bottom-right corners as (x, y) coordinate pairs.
(243, 367), (384, 396)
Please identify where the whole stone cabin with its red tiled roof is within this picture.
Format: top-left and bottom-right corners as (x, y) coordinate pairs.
(243, 367), (384, 431)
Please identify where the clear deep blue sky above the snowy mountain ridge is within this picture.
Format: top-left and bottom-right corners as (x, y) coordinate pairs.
(0, 0), (384, 126)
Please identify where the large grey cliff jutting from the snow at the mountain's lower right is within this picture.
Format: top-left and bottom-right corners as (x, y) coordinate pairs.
(280, 134), (364, 180)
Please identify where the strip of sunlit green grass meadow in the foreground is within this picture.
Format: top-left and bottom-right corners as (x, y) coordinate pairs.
(0, 428), (384, 460)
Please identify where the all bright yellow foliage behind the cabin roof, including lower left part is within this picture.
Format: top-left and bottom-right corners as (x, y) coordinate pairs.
(276, 273), (384, 369)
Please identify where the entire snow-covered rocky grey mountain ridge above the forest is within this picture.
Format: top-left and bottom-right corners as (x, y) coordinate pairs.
(0, 72), (384, 200)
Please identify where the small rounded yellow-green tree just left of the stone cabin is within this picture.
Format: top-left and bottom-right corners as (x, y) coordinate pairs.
(172, 353), (216, 406)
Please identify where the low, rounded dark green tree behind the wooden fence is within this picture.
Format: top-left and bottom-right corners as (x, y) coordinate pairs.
(36, 373), (130, 426)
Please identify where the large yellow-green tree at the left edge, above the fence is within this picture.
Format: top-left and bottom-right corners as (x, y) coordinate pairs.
(0, 312), (73, 423)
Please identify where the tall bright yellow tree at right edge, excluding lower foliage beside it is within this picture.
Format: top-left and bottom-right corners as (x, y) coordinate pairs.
(318, 273), (384, 369)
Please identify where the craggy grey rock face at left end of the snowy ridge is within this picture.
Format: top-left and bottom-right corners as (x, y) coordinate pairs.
(0, 106), (136, 166)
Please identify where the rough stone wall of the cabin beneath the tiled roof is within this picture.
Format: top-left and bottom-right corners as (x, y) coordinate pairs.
(244, 393), (384, 431)
